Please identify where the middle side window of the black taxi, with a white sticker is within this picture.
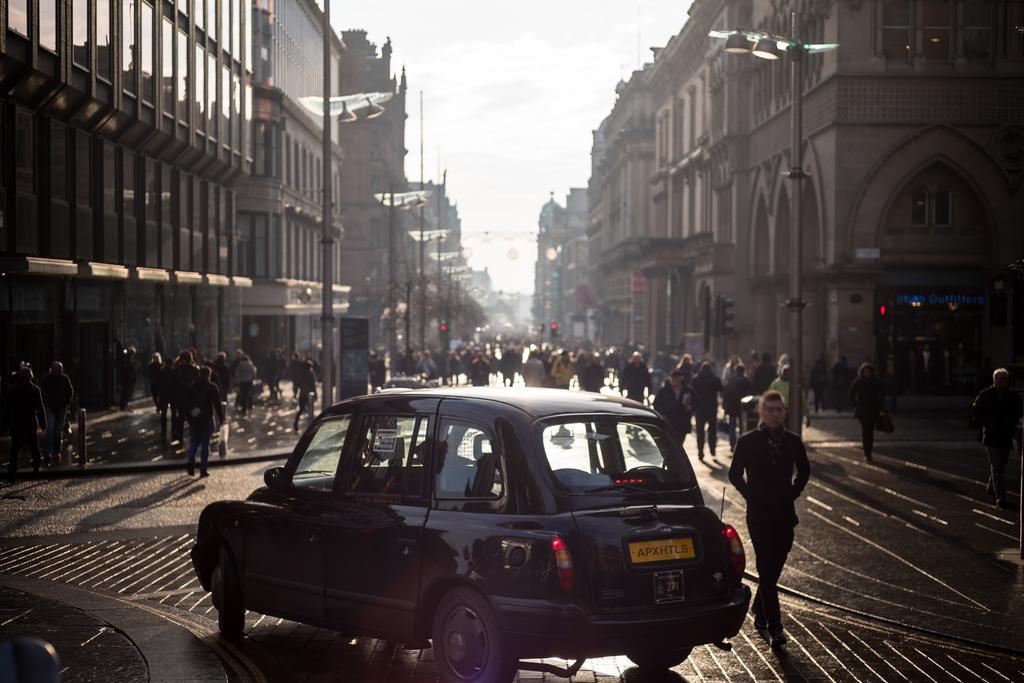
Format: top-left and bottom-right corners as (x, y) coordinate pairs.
(348, 415), (427, 496)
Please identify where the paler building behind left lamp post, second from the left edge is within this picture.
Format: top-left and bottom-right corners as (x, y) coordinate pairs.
(238, 0), (350, 365)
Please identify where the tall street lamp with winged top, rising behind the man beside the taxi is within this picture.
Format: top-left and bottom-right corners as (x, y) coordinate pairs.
(708, 17), (839, 434)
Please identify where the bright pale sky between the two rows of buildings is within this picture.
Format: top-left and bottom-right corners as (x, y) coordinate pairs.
(331, 0), (690, 293)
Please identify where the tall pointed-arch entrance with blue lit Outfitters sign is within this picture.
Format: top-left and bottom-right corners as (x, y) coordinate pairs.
(874, 159), (991, 394)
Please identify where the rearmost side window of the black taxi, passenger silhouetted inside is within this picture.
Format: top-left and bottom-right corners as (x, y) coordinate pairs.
(435, 420), (505, 499)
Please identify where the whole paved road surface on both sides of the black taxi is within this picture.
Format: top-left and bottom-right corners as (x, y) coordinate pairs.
(0, 413), (1024, 682)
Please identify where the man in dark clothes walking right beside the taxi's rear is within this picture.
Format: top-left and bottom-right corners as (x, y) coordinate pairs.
(729, 391), (811, 647)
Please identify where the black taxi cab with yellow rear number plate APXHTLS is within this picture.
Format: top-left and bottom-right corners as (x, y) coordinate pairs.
(191, 388), (751, 683)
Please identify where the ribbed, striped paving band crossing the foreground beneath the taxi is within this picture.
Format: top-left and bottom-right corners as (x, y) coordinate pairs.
(0, 533), (1024, 682)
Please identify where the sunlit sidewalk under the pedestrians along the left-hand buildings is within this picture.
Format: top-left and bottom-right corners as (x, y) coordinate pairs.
(6, 386), (309, 476)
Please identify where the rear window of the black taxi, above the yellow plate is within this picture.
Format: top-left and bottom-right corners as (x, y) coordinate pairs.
(541, 417), (695, 494)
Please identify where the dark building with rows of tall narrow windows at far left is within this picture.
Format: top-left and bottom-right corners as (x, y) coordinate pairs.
(0, 0), (252, 408)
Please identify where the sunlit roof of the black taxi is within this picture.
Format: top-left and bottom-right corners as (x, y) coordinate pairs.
(328, 386), (654, 418)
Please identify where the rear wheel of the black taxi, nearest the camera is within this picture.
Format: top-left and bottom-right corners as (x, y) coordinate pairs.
(431, 588), (517, 683)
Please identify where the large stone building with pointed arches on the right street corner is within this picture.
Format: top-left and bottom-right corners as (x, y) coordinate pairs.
(593, 0), (1024, 393)
